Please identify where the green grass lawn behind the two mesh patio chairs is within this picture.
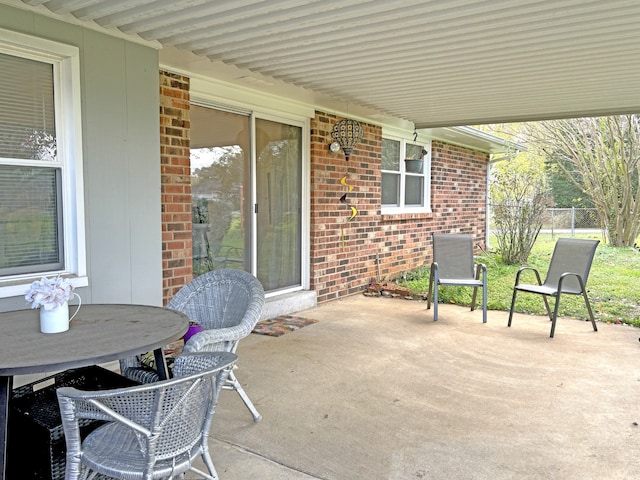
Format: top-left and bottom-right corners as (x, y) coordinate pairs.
(399, 234), (640, 327)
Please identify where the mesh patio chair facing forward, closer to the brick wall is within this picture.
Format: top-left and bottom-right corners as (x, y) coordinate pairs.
(427, 233), (487, 323)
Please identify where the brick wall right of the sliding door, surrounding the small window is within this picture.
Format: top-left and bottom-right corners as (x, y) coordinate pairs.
(311, 112), (488, 303)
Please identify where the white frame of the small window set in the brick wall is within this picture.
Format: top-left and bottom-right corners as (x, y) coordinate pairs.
(380, 131), (431, 215)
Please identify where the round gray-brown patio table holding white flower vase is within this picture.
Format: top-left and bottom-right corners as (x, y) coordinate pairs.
(0, 304), (189, 480)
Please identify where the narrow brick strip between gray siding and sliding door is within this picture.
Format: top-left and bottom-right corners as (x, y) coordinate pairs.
(160, 71), (192, 304)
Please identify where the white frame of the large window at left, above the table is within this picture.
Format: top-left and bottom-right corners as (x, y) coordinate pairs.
(0, 28), (88, 298)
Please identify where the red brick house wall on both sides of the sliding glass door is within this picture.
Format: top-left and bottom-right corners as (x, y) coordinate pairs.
(160, 90), (488, 304)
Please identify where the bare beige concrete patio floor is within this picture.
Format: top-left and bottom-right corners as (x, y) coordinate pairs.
(204, 295), (640, 480)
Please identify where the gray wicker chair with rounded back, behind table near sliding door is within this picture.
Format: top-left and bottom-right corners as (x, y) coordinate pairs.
(120, 269), (264, 422)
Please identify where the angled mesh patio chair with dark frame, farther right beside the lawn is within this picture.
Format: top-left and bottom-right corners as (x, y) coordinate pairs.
(507, 238), (600, 338)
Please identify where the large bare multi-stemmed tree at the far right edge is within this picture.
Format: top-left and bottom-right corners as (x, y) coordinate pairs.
(527, 115), (640, 247)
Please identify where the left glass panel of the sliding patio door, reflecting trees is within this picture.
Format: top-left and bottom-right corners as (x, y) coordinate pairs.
(191, 105), (251, 276)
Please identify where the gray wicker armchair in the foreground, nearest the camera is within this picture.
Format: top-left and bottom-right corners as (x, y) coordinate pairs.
(57, 352), (237, 480)
